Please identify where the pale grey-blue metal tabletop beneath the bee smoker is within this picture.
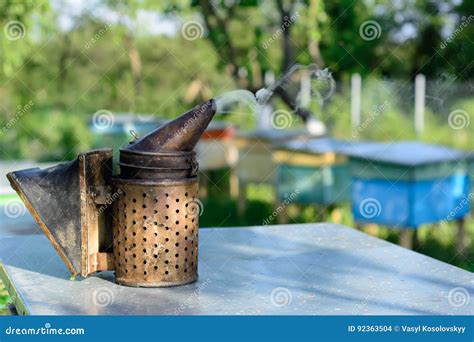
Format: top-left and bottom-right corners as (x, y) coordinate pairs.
(0, 224), (474, 315)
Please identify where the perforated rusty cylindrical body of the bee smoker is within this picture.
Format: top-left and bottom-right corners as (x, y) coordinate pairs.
(113, 182), (199, 287)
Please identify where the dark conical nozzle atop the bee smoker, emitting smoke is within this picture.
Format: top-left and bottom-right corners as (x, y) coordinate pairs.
(122, 100), (216, 152)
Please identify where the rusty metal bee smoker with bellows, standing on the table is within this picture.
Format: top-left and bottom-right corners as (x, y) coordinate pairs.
(7, 100), (216, 287)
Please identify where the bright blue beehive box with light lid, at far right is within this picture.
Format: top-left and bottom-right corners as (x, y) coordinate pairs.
(349, 142), (471, 228)
